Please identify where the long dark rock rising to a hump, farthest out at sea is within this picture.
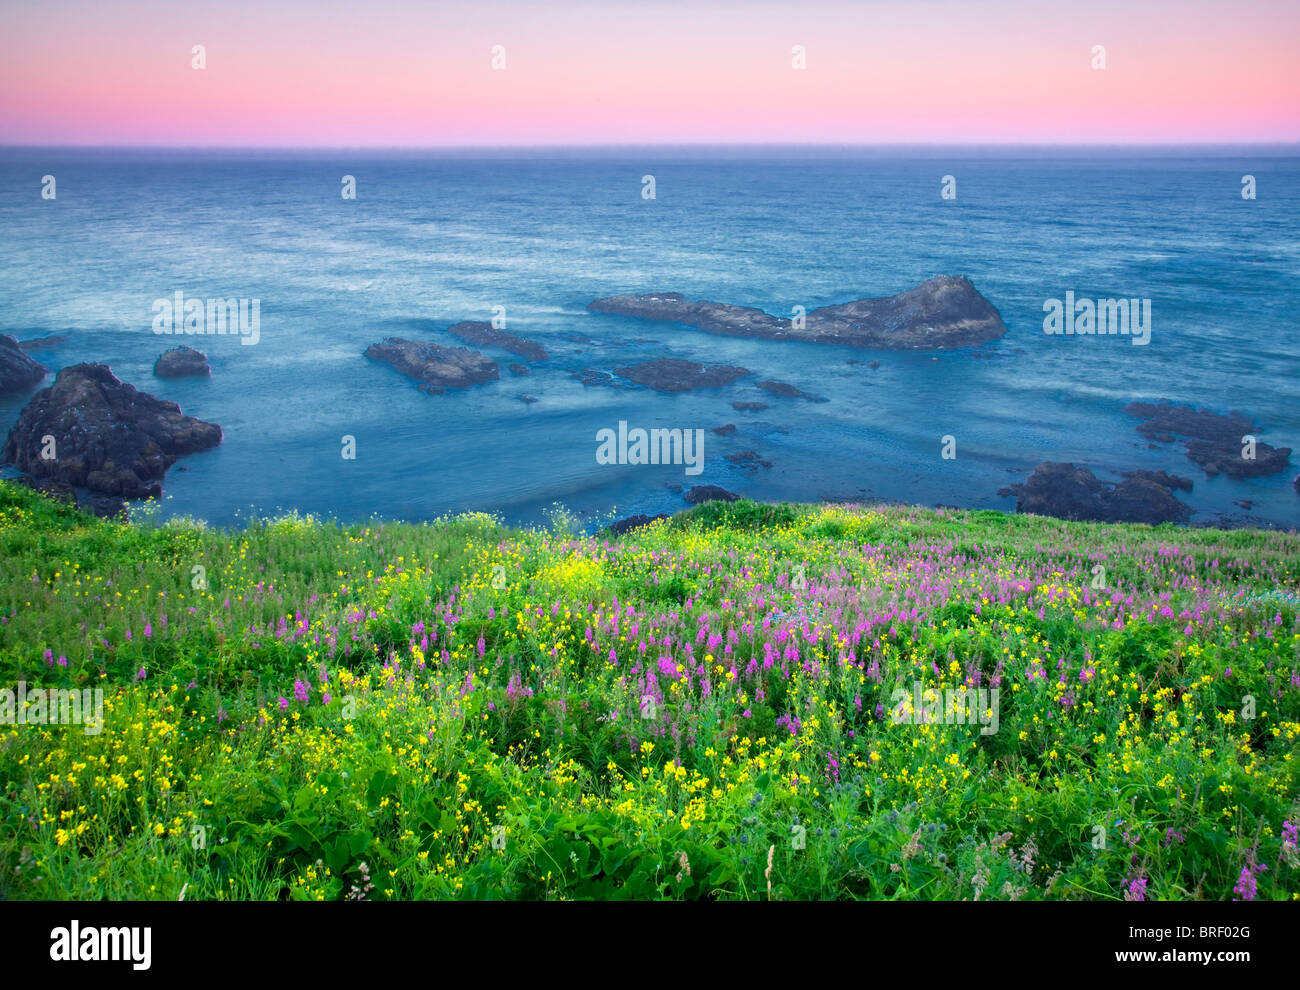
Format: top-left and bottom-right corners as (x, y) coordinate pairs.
(588, 275), (1006, 351)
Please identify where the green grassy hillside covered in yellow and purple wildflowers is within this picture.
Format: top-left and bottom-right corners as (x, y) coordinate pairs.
(0, 483), (1300, 900)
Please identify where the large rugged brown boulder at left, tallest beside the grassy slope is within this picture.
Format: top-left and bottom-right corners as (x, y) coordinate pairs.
(0, 364), (221, 499)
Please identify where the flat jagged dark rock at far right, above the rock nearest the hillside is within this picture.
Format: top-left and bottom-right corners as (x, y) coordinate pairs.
(1125, 399), (1291, 478)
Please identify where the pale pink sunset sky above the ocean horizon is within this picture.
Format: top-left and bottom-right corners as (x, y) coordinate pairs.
(0, 0), (1300, 147)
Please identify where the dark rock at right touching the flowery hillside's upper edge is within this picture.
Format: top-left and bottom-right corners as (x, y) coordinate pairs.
(1002, 461), (1192, 525)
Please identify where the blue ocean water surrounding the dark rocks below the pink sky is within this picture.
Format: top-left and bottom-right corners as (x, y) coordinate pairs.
(0, 148), (1300, 527)
